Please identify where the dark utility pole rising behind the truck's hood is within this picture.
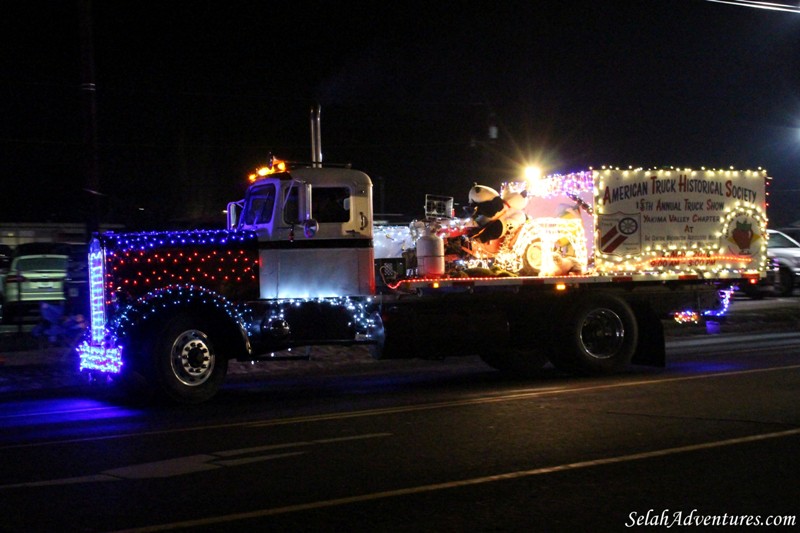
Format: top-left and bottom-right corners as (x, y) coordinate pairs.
(78, 0), (100, 242)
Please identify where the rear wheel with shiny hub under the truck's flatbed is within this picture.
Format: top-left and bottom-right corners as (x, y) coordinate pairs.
(551, 294), (639, 375)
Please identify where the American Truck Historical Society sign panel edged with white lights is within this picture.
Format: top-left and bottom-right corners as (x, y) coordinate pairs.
(595, 169), (767, 277)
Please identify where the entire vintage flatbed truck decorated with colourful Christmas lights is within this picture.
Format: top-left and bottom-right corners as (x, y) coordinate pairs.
(78, 160), (767, 403)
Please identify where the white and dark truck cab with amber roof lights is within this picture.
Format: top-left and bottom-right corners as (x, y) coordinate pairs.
(229, 163), (375, 299)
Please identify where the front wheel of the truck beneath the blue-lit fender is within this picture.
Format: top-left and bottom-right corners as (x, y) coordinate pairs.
(151, 314), (228, 404)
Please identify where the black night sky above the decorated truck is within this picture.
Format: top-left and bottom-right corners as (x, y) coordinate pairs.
(0, 0), (800, 229)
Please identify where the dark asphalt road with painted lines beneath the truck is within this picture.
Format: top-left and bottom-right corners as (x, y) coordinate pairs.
(0, 326), (800, 532)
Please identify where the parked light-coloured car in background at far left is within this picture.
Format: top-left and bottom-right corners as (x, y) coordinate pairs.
(0, 245), (67, 322)
